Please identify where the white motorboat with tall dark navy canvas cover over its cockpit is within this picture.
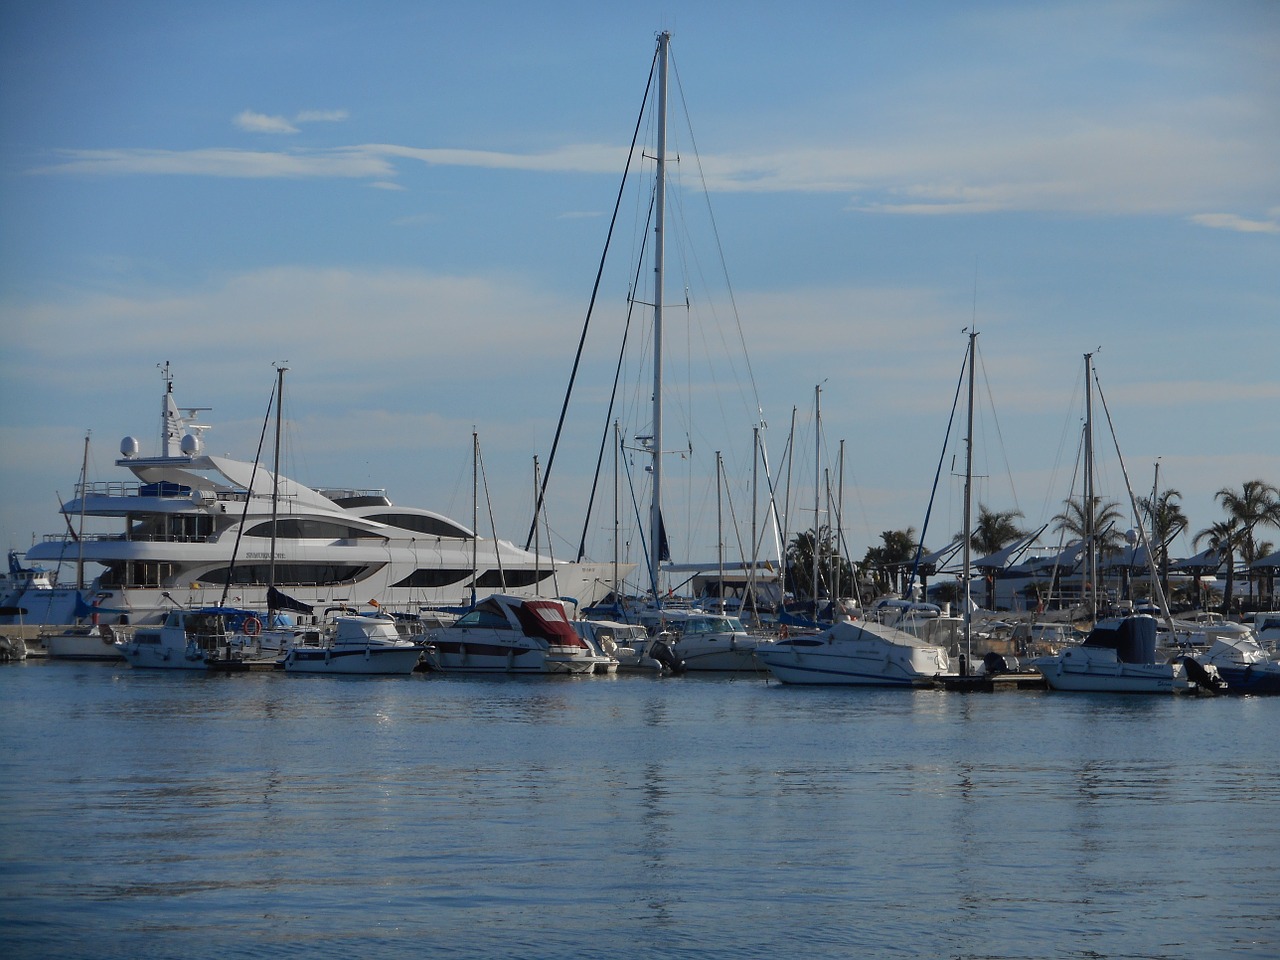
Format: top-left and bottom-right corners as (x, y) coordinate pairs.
(1034, 614), (1196, 694)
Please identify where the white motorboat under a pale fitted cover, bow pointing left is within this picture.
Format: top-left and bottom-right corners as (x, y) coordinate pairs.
(756, 621), (956, 687)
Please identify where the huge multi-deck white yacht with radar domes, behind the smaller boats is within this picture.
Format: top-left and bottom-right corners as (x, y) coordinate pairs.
(12, 365), (630, 625)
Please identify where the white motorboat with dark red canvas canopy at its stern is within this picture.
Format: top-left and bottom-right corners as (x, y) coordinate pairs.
(426, 594), (617, 675)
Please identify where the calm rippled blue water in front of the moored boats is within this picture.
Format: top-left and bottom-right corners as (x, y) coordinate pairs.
(0, 662), (1280, 960)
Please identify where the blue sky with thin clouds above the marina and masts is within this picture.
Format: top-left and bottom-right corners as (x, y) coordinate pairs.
(0, 0), (1280, 586)
